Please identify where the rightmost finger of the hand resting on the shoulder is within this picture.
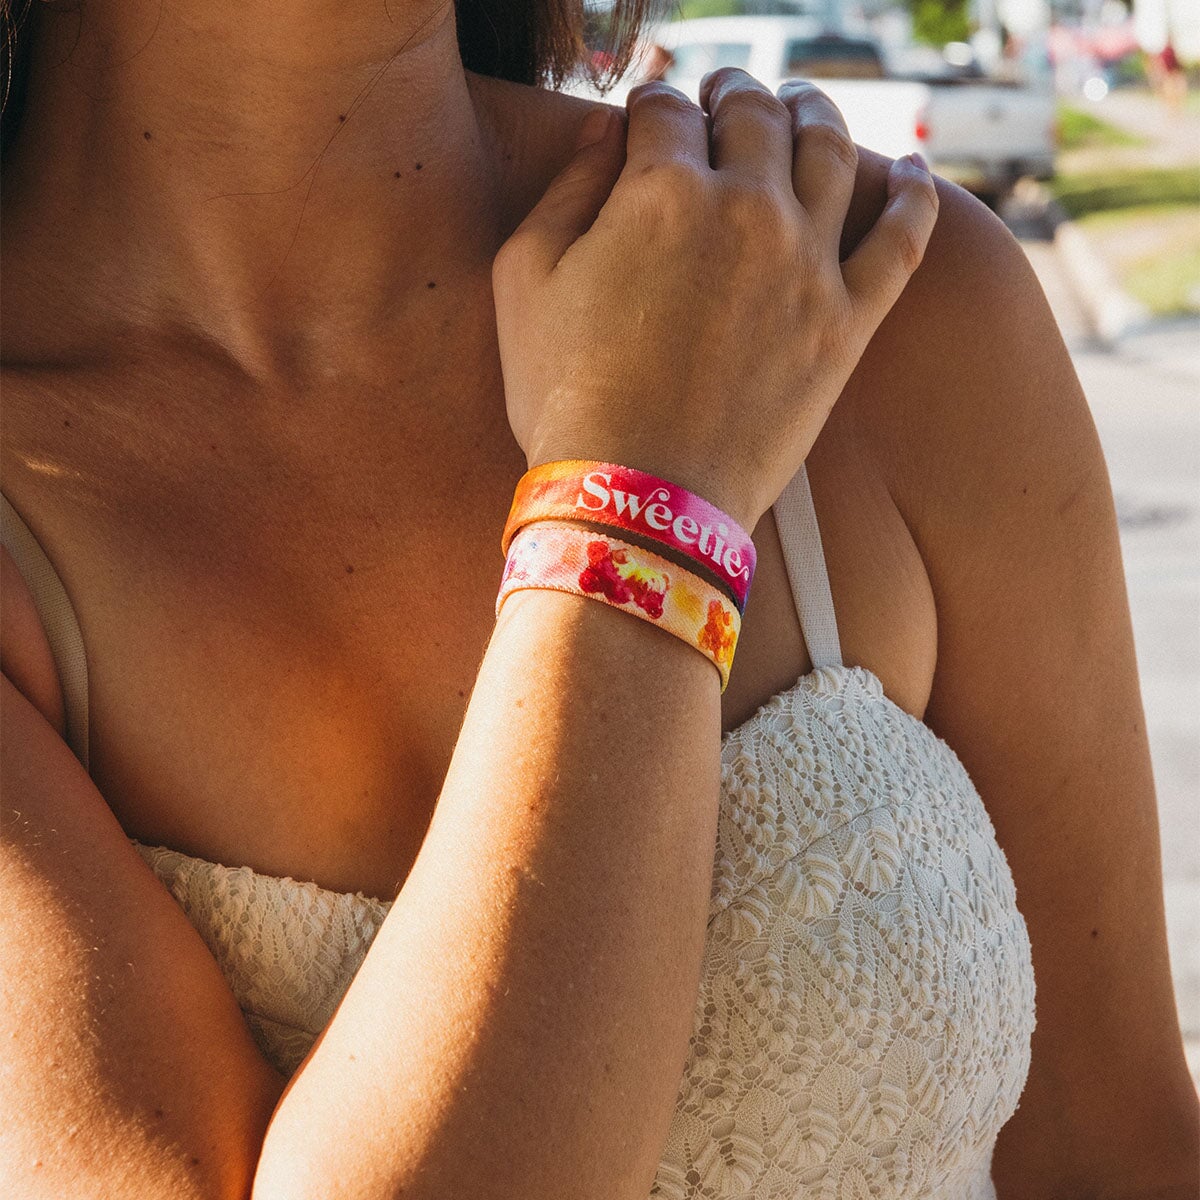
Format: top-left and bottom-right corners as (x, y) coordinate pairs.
(841, 156), (937, 332)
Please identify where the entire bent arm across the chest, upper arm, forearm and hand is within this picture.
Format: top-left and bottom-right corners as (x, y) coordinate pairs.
(0, 72), (936, 1200)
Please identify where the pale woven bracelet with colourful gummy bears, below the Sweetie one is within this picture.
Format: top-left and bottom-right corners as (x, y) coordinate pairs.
(496, 521), (742, 691)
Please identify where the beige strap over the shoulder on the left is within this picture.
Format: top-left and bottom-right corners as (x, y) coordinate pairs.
(0, 492), (88, 770)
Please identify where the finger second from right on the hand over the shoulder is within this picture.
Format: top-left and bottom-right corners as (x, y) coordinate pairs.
(779, 79), (858, 252)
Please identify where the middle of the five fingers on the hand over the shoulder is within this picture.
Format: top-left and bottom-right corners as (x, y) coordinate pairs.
(700, 67), (792, 193)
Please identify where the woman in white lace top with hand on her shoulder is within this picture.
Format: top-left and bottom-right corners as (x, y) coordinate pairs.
(0, 0), (1195, 1200)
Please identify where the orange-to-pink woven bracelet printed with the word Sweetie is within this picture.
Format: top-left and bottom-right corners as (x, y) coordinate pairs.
(500, 458), (756, 613)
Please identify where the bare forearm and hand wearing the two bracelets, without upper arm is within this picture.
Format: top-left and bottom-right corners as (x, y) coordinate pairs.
(254, 82), (935, 1200)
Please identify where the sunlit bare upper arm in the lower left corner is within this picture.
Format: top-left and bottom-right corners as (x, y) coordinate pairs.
(0, 657), (282, 1200)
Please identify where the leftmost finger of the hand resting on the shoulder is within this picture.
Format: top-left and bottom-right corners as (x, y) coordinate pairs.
(492, 104), (625, 281)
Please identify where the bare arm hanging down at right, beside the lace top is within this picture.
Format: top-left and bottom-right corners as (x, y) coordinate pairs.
(869, 187), (1200, 1200)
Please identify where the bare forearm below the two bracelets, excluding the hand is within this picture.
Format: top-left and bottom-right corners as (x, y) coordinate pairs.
(256, 590), (720, 1200)
